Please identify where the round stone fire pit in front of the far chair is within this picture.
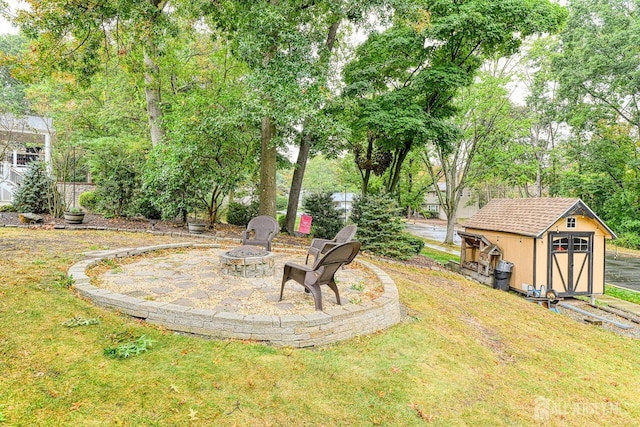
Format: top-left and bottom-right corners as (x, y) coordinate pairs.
(220, 245), (276, 277)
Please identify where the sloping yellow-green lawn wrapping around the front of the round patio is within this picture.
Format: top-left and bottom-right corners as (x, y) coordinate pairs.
(0, 228), (640, 426)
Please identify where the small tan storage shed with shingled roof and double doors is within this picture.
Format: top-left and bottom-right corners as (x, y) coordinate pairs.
(459, 198), (616, 297)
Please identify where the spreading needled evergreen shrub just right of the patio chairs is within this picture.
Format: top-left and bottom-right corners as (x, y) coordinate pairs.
(351, 195), (424, 259)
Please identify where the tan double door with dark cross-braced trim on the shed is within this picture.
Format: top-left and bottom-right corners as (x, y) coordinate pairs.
(547, 232), (594, 297)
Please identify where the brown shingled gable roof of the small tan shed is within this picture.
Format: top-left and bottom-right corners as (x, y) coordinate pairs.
(464, 197), (616, 238)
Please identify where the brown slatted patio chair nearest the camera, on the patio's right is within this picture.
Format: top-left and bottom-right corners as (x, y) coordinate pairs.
(279, 241), (360, 311)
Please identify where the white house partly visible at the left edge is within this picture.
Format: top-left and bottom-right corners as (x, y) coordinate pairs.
(0, 114), (55, 205)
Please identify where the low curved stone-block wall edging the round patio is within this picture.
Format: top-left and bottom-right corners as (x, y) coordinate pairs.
(67, 243), (401, 347)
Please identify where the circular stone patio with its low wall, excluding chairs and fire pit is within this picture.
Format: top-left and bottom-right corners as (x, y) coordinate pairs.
(68, 243), (400, 347)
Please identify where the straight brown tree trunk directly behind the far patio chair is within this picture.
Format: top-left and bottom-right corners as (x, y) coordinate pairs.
(258, 117), (277, 218)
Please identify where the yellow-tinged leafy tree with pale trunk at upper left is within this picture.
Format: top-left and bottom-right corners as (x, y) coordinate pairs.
(16, 0), (197, 145)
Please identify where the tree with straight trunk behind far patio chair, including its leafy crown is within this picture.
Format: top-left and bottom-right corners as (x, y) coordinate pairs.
(213, 0), (358, 217)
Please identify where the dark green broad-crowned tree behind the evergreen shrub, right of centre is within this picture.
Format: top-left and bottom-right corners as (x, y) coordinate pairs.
(345, 0), (565, 224)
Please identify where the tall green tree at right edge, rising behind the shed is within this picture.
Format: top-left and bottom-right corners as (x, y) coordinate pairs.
(553, 0), (640, 242)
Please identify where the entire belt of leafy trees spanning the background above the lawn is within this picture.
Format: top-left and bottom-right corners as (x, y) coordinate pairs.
(6, 0), (640, 249)
